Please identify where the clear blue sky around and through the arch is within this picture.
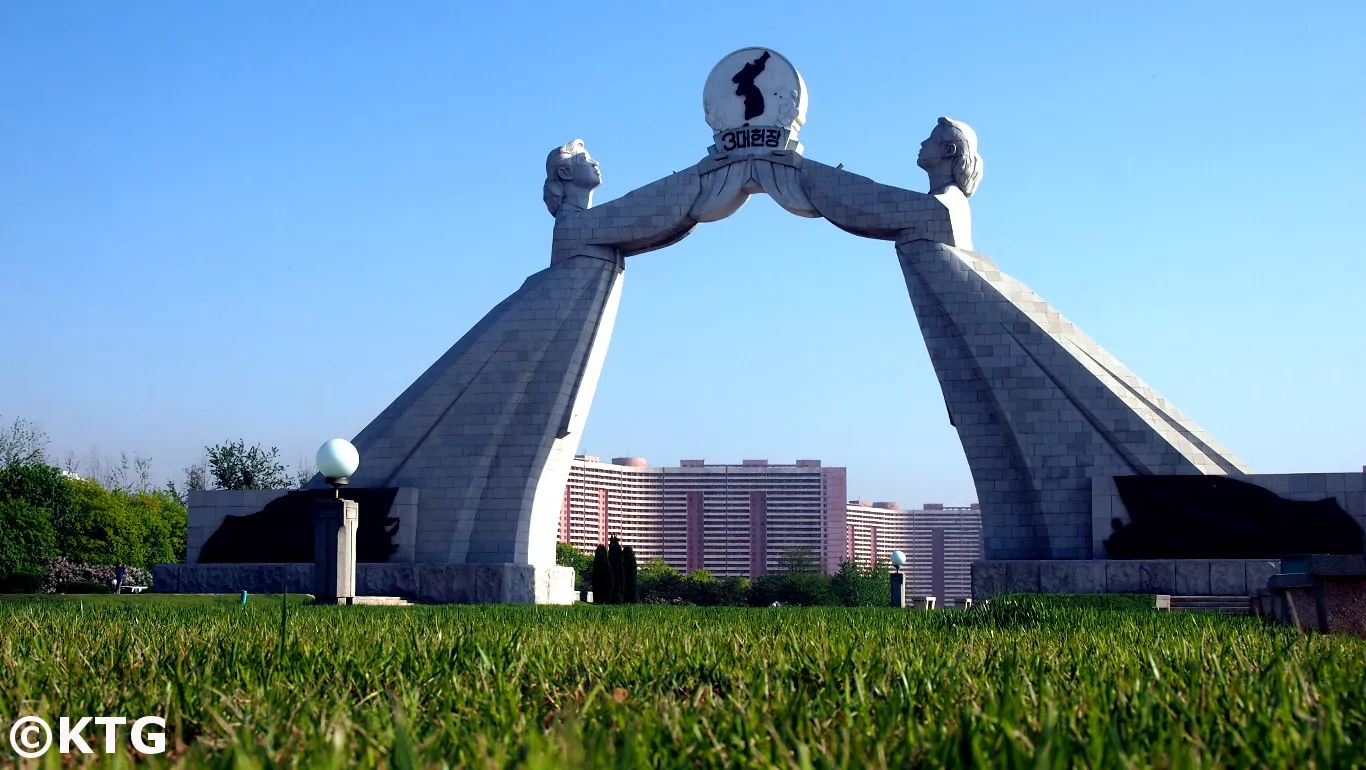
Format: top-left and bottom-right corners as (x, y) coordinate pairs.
(0, 0), (1366, 504)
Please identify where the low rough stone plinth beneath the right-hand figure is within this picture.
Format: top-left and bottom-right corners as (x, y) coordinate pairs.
(973, 558), (1280, 601)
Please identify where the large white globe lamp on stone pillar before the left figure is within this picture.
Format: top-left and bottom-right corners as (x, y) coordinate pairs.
(313, 438), (361, 605)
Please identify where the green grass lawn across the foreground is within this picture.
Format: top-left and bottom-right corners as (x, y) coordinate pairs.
(0, 595), (1366, 767)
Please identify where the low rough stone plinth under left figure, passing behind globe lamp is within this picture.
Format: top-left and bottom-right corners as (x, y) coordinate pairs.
(152, 564), (574, 605)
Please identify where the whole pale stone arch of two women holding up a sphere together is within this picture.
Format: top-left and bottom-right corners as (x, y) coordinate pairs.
(165, 48), (1361, 602)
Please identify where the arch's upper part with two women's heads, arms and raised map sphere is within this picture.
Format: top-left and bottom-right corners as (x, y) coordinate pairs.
(544, 48), (982, 265)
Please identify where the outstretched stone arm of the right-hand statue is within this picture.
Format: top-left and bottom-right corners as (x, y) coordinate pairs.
(802, 158), (953, 244)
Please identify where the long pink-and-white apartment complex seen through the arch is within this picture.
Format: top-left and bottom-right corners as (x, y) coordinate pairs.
(559, 455), (982, 599)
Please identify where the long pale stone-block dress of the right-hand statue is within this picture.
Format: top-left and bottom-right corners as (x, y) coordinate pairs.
(897, 240), (1247, 562)
